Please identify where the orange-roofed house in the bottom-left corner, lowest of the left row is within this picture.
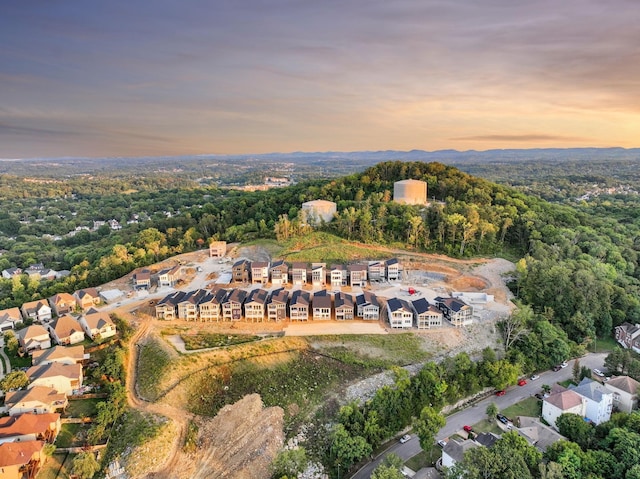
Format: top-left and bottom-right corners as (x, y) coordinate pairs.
(0, 441), (47, 479)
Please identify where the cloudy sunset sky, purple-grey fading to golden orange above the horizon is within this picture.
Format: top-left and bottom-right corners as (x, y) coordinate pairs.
(0, 0), (640, 158)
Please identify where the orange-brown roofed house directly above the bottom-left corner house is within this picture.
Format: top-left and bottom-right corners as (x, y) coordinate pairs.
(0, 413), (60, 444)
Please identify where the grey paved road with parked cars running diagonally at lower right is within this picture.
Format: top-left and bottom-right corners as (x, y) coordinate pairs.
(352, 353), (607, 479)
